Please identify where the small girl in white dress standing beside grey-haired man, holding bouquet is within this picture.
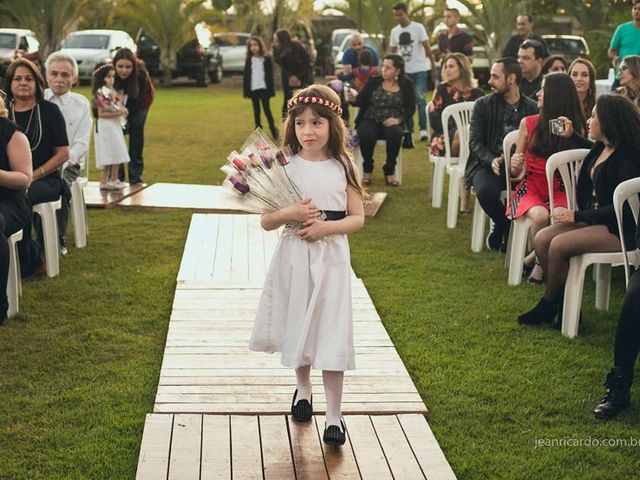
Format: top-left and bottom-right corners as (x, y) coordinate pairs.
(91, 62), (129, 190)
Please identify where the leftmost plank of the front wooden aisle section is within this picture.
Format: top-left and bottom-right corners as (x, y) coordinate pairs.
(136, 413), (173, 480)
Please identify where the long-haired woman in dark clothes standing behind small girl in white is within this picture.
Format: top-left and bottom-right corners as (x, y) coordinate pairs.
(113, 48), (155, 185)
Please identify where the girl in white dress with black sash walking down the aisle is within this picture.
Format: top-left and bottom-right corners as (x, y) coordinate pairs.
(250, 85), (364, 445)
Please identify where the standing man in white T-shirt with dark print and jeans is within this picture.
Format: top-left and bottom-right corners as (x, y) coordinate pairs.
(389, 3), (437, 140)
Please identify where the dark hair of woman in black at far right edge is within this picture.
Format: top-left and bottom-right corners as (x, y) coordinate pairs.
(596, 95), (640, 153)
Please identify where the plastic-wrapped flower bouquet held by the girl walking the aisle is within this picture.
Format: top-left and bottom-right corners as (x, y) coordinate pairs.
(221, 128), (305, 213)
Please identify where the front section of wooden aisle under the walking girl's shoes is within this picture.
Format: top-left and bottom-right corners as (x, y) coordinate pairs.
(136, 414), (455, 480)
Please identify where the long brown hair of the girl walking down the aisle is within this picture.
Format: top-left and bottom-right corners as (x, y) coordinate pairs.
(282, 85), (365, 198)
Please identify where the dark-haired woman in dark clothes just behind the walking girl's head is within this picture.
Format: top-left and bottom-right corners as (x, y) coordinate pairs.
(273, 29), (313, 118)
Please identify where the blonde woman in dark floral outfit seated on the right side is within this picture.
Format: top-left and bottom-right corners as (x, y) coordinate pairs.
(429, 53), (484, 213)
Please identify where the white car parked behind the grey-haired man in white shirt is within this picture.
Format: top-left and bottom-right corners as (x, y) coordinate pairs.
(61, 30), (136, 81)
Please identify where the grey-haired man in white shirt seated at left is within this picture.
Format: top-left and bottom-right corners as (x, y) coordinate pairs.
(44, 52), (92, 255)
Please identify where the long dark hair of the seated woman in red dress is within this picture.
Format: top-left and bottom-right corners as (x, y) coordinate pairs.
(529, 73), (586, 158)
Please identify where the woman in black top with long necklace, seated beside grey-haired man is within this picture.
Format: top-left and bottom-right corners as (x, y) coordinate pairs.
(4, 58), (69, 277)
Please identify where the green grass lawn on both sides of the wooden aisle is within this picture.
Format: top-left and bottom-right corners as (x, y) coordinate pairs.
(0, 84), (640, 479)
